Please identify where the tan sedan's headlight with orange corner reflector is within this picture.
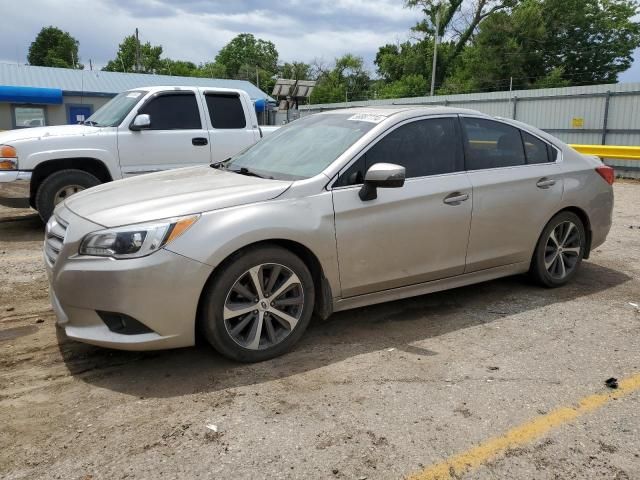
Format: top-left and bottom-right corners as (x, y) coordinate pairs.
(79, 215), (199, 259)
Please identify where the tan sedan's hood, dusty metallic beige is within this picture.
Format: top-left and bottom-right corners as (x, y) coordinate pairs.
(65, 166), (292, 227)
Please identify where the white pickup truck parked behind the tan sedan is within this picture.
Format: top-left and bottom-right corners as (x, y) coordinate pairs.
(0, 87), (277, 221)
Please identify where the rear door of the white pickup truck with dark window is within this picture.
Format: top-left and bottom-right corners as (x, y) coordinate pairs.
(203, 90), (259, 162)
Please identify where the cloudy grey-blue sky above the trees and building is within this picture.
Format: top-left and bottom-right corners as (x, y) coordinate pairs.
(0, 0), (640, 82)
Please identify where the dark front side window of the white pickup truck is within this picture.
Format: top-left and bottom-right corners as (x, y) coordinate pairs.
(138, 92), (202, 130)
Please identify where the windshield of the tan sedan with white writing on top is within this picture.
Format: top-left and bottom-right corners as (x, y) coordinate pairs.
(226, 113), (384, 180)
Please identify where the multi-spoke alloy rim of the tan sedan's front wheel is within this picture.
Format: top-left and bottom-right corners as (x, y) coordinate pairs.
(223, 263), (304, 350)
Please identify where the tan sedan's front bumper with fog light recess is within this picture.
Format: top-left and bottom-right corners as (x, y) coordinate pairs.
(44, 204), (212, 350)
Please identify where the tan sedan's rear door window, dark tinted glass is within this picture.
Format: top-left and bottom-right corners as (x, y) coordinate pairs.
(462, 117), (525, 170)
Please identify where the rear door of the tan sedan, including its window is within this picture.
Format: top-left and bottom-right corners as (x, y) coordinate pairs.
(461, 117), (563, 272)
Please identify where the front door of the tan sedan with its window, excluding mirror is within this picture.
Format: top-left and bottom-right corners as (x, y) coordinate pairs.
(333, 117), (472, 298)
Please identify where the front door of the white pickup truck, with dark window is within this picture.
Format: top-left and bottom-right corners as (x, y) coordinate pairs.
(118, 90), (211, 177)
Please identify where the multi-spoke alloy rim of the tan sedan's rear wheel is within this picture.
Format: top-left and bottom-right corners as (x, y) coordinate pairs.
(544, 220), (582, 280)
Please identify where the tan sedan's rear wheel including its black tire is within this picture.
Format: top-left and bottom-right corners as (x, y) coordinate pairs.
(529, 212), (586, 288)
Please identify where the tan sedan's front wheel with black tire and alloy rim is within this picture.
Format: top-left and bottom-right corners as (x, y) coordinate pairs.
(200, 246), (315, 362)
